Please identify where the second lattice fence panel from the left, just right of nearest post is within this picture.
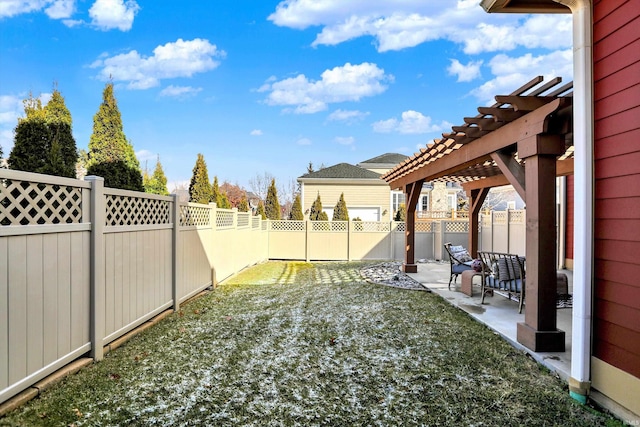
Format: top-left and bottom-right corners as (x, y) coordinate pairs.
(105, 194), (171, 226)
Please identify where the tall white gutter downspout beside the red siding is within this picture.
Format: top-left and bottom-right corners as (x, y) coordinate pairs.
(554, 0), (594, 403)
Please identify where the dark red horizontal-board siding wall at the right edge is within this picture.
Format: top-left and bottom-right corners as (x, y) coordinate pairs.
(592, 0), (640, 378)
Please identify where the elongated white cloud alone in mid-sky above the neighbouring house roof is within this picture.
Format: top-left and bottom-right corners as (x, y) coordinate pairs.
(258, 62), (393, 114)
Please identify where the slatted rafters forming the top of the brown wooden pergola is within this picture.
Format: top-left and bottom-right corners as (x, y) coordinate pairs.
(382, 76), (573, 187)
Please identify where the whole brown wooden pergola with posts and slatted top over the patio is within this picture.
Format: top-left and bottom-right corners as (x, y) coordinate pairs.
(382, 77), (573, 351)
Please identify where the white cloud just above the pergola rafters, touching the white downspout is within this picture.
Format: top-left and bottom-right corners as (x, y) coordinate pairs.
(471, 49), (573, 105)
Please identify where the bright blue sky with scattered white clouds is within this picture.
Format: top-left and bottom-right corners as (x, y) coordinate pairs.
(0, 0), (572, 196)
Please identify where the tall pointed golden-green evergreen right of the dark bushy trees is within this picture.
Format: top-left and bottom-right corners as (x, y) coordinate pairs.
(87, 83), (144, 191)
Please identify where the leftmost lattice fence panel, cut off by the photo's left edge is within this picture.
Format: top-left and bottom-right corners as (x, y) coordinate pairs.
(0, 179), (82, 225)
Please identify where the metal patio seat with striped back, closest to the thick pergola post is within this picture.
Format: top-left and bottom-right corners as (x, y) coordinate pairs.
(478, 252), (525, 313)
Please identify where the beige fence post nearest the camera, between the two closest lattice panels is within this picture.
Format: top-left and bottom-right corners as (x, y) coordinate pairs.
(84, 175), (106, 361)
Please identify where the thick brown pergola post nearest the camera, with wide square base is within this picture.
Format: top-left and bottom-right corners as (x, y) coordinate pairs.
(517, 134), (565, 352)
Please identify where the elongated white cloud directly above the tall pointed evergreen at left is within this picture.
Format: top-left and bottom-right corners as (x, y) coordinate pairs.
(91, 39), (226, 89)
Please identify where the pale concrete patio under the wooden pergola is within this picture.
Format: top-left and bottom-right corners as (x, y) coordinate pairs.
(408, 261), (573, 380)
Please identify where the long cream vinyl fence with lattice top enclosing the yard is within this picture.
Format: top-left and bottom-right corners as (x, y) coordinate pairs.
(0, 169), (524, 403)
